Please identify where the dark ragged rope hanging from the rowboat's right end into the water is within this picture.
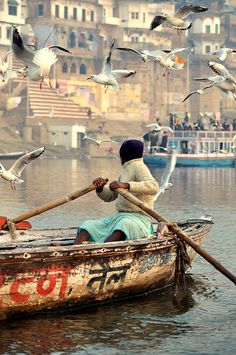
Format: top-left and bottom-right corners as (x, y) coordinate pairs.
(174, 236), (191, 296)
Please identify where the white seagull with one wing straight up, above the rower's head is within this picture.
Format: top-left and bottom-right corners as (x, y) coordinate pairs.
(87, 40), (136, 92)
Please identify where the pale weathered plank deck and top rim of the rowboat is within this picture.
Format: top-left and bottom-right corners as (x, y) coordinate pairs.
(0, 216), (213, 254)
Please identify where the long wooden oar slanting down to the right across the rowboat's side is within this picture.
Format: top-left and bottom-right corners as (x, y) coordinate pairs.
(116, 188), (236, 285)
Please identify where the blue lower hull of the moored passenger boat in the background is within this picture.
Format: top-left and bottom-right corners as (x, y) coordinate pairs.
(144, 153), (236, 167)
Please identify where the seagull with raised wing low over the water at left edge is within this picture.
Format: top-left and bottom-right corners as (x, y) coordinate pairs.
(0, 147), (45, 190)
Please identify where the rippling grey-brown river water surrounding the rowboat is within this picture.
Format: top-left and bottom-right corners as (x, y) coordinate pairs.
(0, 158), (236, 355)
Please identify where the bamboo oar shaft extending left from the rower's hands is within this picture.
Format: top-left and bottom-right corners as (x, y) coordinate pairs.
(10, 184), (96, 223)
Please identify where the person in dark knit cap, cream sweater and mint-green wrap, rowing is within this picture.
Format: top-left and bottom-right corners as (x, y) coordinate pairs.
(74, 139), (159, 244)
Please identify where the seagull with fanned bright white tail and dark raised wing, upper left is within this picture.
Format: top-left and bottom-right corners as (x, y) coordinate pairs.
(12, 27), (71, 89)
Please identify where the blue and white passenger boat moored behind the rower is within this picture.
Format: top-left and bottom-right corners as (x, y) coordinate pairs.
(144, 131), (236, 167)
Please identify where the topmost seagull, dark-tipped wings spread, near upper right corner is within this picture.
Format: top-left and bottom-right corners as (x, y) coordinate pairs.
(150, 5), (208, 30)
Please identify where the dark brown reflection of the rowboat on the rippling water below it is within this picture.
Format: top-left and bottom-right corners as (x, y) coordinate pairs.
(0, 276), (208, 354)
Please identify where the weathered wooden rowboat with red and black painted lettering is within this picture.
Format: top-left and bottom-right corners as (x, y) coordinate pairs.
(0, 219), (211, 319)
